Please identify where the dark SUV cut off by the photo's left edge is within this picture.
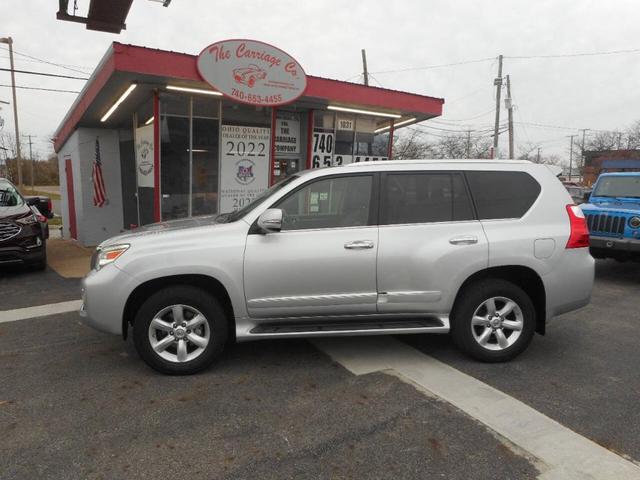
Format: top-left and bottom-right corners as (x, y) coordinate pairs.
(0, 178), (48, 270)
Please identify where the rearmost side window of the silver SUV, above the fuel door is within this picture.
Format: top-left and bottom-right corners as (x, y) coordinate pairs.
(466, 171), (541, 220)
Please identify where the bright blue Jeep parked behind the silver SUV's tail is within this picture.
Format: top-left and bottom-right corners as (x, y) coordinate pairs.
(580, 172), (640, 260)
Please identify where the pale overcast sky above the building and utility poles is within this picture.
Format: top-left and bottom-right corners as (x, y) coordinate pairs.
(0, 0), (640, 161)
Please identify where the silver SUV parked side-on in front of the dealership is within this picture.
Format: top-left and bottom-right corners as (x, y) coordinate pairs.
(81, 160), (594, 374)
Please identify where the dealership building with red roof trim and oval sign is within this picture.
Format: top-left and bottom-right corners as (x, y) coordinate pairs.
(55, 40), (444, 246)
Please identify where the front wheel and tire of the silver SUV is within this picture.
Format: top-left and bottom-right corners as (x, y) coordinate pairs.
(133, 285), (228, 375)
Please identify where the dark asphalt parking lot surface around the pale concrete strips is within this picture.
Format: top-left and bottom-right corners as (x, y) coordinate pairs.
(0, 261), (640, 480)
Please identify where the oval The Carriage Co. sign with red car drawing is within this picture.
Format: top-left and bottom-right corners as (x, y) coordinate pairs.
(198, 40), (307, 107)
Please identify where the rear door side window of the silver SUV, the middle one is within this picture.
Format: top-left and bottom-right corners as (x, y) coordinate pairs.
(381, 172), (474, 225)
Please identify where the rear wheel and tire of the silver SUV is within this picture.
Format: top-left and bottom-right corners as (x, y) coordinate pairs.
(451, 279), (536, 362)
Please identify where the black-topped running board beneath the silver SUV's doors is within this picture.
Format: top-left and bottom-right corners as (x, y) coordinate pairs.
(249, 318), (449, 337)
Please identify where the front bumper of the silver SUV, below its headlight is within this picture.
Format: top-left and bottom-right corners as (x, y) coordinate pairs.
(79, 264), (135, 335)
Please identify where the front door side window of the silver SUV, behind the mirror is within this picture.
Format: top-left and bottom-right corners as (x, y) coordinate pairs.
(274, 175), (373, 230)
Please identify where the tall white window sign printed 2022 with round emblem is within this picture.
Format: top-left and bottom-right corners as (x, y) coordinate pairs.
(219, 125), (271, 213)
